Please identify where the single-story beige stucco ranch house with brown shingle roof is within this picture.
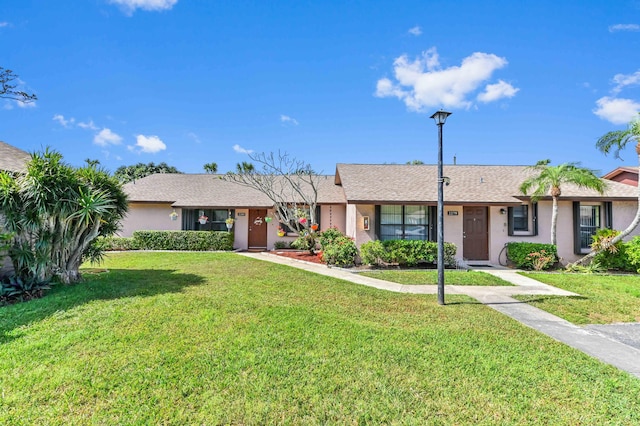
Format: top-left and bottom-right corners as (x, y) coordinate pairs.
(121, 164), (638, 264)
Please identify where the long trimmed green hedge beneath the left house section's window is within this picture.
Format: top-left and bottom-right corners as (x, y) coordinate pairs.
(96, 231), (233, 251)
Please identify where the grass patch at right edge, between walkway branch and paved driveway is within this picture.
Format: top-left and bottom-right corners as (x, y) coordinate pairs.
(516, 273), (640, 324)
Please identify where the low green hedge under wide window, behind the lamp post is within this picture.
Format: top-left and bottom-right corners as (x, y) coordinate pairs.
(360, 240), (457, 267)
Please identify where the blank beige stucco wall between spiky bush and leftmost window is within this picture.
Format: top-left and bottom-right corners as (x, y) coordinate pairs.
(118, 203), (182, 237)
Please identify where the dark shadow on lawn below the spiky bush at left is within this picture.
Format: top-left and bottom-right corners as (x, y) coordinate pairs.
(0, 269), (205, 344)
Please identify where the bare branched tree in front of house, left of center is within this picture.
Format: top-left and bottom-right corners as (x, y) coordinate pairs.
(221, 152), (320, 233)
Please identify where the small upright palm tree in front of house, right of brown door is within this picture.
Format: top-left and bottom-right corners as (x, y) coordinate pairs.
(520, 160), (606, 245)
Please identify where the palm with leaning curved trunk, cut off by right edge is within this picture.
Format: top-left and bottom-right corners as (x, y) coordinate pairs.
(575, 114), (640, 265)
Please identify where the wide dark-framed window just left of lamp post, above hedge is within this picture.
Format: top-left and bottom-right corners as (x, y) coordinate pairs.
(376, 205), (430, 241)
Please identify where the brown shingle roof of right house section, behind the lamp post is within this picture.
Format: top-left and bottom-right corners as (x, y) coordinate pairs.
(336, 164), (637, 205)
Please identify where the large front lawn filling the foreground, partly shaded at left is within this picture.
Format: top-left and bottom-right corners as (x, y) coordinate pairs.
(0, 253), (640, 425)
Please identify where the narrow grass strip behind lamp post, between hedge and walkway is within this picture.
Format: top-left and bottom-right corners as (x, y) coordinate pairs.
(360, 270), (512, 286)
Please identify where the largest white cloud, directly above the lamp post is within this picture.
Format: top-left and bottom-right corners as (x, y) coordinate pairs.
(375, 48), (519, 111)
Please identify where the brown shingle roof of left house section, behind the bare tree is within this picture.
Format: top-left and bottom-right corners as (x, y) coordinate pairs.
(124, 173), (345, 208)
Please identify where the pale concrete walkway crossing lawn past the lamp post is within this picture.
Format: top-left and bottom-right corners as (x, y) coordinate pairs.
(239, 252), (640, 378)
